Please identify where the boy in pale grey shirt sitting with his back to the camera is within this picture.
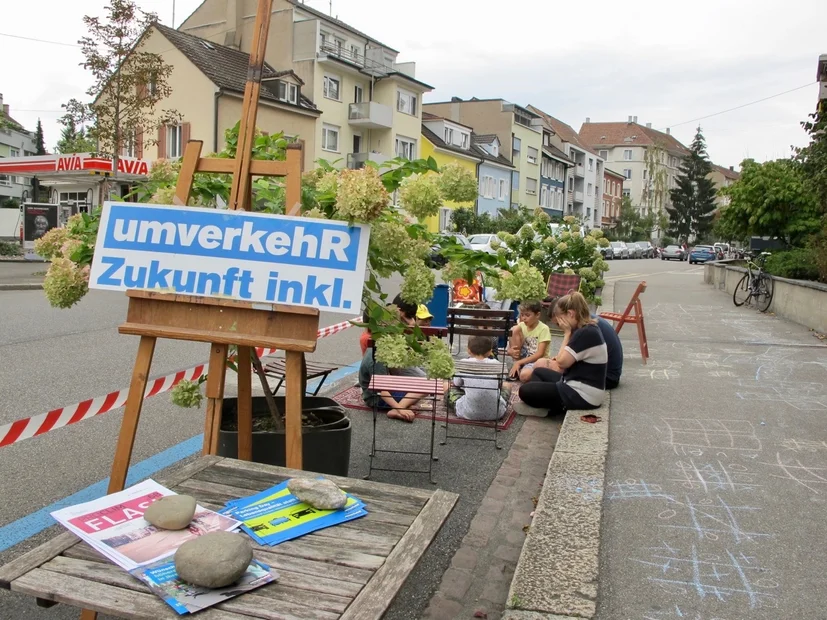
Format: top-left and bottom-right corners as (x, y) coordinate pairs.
(446, 336), (506, 421)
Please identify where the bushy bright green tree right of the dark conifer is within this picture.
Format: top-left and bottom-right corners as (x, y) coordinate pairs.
(718, 159), (821, 246)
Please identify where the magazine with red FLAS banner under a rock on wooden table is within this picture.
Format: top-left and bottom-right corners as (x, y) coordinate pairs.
(52, 480), (241, 571)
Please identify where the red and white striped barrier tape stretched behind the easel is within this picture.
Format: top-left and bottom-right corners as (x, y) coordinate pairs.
(0, 317), (361, 448)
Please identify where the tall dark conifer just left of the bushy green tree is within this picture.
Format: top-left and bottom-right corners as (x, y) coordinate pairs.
(668, 126), (715, 241)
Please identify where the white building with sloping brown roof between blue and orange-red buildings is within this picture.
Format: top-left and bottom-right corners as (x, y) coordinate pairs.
(528, 105), (603, 228)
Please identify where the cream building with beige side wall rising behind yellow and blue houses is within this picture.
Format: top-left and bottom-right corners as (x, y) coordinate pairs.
(424, 97), (543, 208)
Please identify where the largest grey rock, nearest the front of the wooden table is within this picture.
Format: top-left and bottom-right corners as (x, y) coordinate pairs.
(175, 532), (253, 588)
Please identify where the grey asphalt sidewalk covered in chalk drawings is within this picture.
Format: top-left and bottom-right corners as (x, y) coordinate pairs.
(596, 274), (827, 620)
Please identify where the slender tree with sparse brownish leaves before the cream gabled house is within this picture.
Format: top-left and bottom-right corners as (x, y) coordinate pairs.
(62, 0), (180, 170)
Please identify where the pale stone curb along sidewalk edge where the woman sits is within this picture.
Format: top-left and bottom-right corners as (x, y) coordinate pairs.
(502, 285), (614, 620)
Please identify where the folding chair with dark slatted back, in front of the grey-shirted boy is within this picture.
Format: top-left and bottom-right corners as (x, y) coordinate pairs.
(441, 308), (514, 450)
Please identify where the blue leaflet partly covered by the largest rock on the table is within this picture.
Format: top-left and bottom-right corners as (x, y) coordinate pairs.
(131, 559), (278, 614)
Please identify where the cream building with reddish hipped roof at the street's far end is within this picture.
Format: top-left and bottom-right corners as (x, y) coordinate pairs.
(580, 116), (689, 222)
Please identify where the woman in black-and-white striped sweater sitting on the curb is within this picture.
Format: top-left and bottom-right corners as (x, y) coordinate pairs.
(514, 293), (608, 416)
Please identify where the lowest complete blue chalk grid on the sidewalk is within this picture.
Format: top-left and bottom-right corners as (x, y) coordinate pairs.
(632, 545), (778, 617)
